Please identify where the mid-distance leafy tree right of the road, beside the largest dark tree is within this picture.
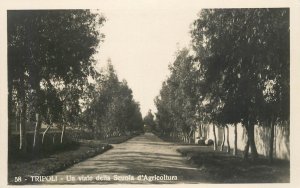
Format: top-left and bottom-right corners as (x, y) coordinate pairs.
(155, 48), (197, 142)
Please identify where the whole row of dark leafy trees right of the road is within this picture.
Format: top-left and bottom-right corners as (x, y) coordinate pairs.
(155, 8), (290, 160)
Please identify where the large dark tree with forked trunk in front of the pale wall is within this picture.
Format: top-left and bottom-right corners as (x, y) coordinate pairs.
(192, 9), (289, 158)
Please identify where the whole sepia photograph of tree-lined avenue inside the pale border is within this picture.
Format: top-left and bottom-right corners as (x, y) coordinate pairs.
(2, 1), (296, 186)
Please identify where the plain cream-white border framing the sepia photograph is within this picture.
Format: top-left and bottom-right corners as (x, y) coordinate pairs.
(0, 0), (300, 188)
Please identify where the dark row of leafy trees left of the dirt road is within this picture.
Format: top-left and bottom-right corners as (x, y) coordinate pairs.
(7, 10), (143, 153)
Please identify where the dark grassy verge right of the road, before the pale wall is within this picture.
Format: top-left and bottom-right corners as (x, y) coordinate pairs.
(177, 146), (290, 183)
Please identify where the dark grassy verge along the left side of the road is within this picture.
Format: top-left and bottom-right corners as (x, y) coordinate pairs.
(8, 136), (137, 184)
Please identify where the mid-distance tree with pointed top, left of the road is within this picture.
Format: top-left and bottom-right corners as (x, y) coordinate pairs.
(81, 61), (143, 139)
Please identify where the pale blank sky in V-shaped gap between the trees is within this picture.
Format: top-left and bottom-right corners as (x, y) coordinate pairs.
(95, 6), (200, 116)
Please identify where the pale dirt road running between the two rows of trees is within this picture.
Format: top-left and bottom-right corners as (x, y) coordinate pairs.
(54, 133), (205, 184)
